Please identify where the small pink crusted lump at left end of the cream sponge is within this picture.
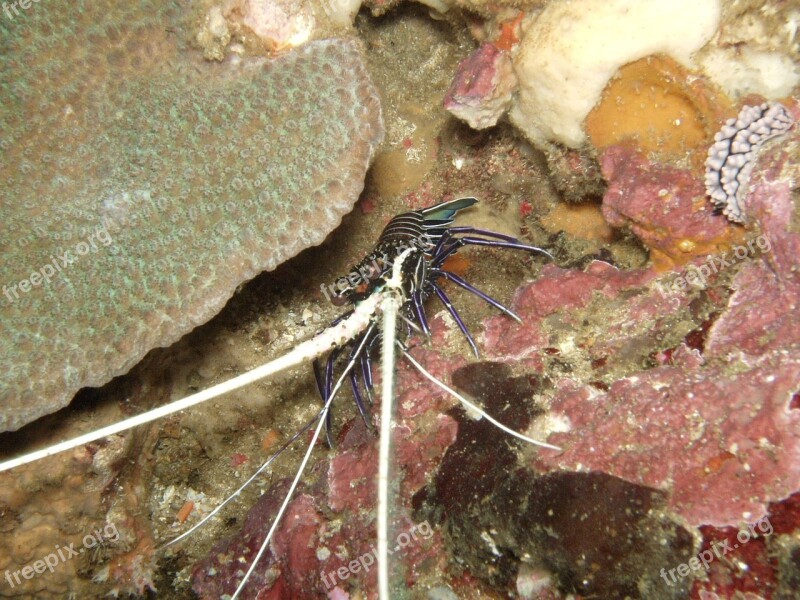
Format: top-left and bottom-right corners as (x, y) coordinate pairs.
(444, 43), (517, 129)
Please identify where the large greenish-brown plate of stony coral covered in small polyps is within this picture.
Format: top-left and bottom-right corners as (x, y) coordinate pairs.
(0, 0), (383, 430)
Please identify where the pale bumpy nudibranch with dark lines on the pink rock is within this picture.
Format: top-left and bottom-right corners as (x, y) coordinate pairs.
(706, 102), (794, 223)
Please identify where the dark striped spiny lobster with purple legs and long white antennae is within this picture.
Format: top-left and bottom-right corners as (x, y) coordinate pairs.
(2, 198), (564, 597)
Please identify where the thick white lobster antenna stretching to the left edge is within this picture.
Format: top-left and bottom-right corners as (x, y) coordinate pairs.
(0, 294), (384, 472)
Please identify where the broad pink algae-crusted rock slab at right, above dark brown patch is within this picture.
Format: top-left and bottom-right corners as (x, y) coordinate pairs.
(537, 357), (800, 526)
